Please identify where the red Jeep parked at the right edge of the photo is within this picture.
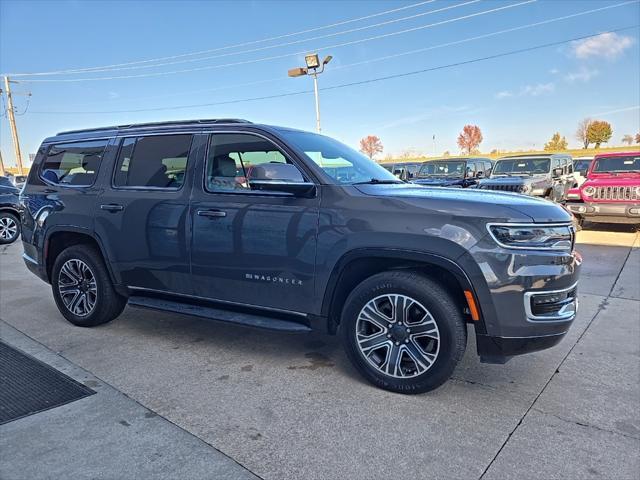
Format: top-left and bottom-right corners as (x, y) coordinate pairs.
(567, 152), (640, 224)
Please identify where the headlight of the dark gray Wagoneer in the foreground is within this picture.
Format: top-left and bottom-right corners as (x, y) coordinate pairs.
(487, 224), (573, 251)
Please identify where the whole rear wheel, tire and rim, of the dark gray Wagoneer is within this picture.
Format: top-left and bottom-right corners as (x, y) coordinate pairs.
(51, 245), (126, 327)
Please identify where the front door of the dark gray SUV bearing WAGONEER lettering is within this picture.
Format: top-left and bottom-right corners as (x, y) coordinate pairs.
(190, 133), (319, 312)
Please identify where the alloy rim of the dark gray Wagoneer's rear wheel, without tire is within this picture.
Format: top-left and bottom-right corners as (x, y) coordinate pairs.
(58, 258), (98, 317)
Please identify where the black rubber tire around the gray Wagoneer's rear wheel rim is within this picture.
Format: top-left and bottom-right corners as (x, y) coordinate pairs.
(51, 245), (127, 327)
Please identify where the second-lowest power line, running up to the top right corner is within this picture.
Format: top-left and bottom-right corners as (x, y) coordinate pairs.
(31, 0), (637, 106)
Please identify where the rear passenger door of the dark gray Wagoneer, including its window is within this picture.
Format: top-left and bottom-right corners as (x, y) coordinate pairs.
(95, 133), (197, 294)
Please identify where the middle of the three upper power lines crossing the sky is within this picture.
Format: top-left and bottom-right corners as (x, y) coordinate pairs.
(10, 0), (480, 75)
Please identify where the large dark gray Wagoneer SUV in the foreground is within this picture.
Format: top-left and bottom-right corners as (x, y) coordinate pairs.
(21, 120), (581, 393)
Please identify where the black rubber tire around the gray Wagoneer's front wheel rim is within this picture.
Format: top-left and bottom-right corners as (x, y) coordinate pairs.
(340, 271), (467, 394)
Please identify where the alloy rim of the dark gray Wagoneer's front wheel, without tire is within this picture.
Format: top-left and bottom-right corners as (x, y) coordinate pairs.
(356, 294), (440, 378)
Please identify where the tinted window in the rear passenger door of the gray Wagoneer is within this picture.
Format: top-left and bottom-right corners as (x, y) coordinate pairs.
(113, 135), (193, 189)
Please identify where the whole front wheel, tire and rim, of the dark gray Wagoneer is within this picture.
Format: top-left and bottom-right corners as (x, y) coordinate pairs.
(340, 272), (467, 393)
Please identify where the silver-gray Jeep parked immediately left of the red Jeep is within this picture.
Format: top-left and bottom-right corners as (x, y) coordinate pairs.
(479, 154), (575, 202)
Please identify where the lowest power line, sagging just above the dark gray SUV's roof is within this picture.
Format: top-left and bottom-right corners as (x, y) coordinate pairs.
(31, 24), (640, 115)
